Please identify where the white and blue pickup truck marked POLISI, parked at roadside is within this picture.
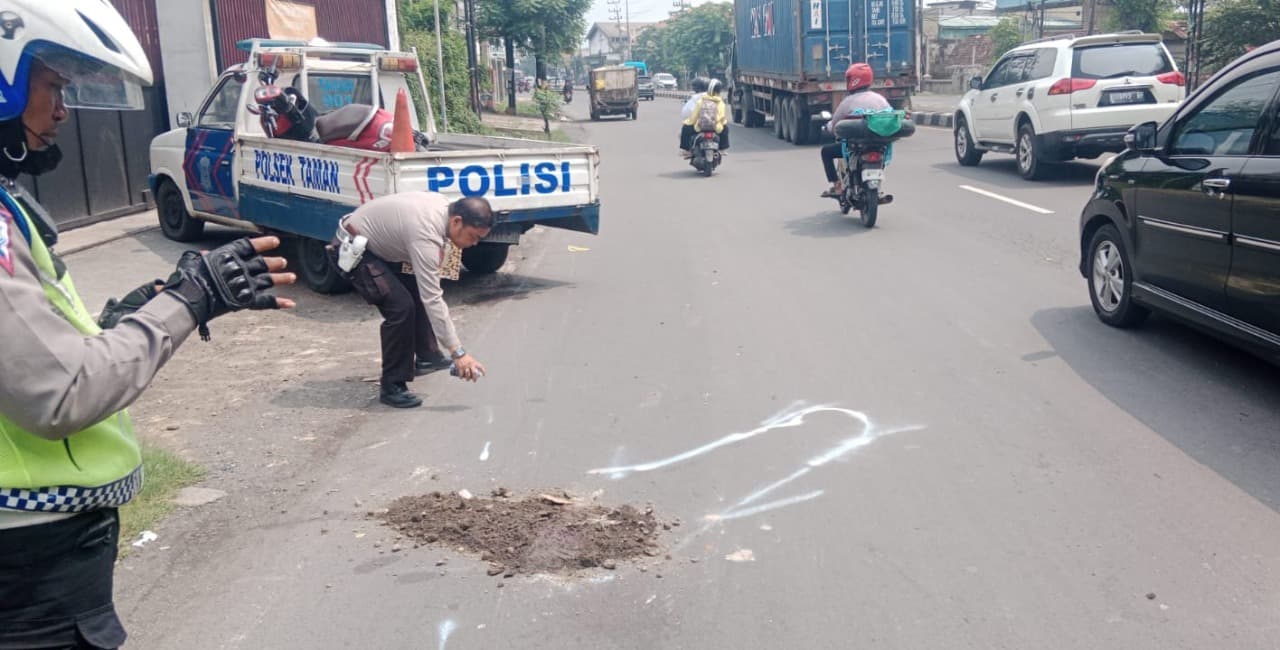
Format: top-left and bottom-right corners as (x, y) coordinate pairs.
(150, 40), (600, 293)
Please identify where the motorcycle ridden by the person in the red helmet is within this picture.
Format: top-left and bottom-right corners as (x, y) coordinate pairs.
(822, 111), (915, 228)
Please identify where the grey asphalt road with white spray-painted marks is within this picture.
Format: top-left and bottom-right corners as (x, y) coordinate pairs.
(102, 100), (1280, 650)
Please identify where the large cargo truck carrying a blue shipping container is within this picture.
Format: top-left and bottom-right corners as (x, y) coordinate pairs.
(728, 0), (916, 145)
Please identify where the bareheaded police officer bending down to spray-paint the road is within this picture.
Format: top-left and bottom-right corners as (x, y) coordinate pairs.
(338, 192), (493, 408)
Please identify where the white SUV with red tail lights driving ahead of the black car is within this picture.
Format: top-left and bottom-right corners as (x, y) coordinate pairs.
(955, 32), (1187, 179)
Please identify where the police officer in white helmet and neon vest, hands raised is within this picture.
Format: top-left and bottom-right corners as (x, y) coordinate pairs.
(0, 0), (293, 650)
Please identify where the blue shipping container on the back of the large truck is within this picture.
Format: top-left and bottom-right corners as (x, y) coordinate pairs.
(733, 0), (915, 81)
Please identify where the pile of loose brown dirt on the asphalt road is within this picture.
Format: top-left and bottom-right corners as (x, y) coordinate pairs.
(383, 488), (671, 577)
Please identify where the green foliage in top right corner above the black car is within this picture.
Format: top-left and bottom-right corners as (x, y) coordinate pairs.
(1201, 0), (1280, 73)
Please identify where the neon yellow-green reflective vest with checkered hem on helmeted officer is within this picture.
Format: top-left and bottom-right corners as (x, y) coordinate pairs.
(0, 188), (142, 513)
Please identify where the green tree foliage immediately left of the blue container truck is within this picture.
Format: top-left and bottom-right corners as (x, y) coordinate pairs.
(631, 3), (733, 79)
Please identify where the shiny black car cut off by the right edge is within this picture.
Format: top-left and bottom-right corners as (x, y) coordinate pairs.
(1080, 41), (1280, 362)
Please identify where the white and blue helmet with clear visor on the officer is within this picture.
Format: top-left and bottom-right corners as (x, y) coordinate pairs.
(0, 0), (151, 122)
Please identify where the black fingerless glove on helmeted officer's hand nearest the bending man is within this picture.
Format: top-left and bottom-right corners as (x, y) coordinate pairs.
(164, 238), (279, 340)
